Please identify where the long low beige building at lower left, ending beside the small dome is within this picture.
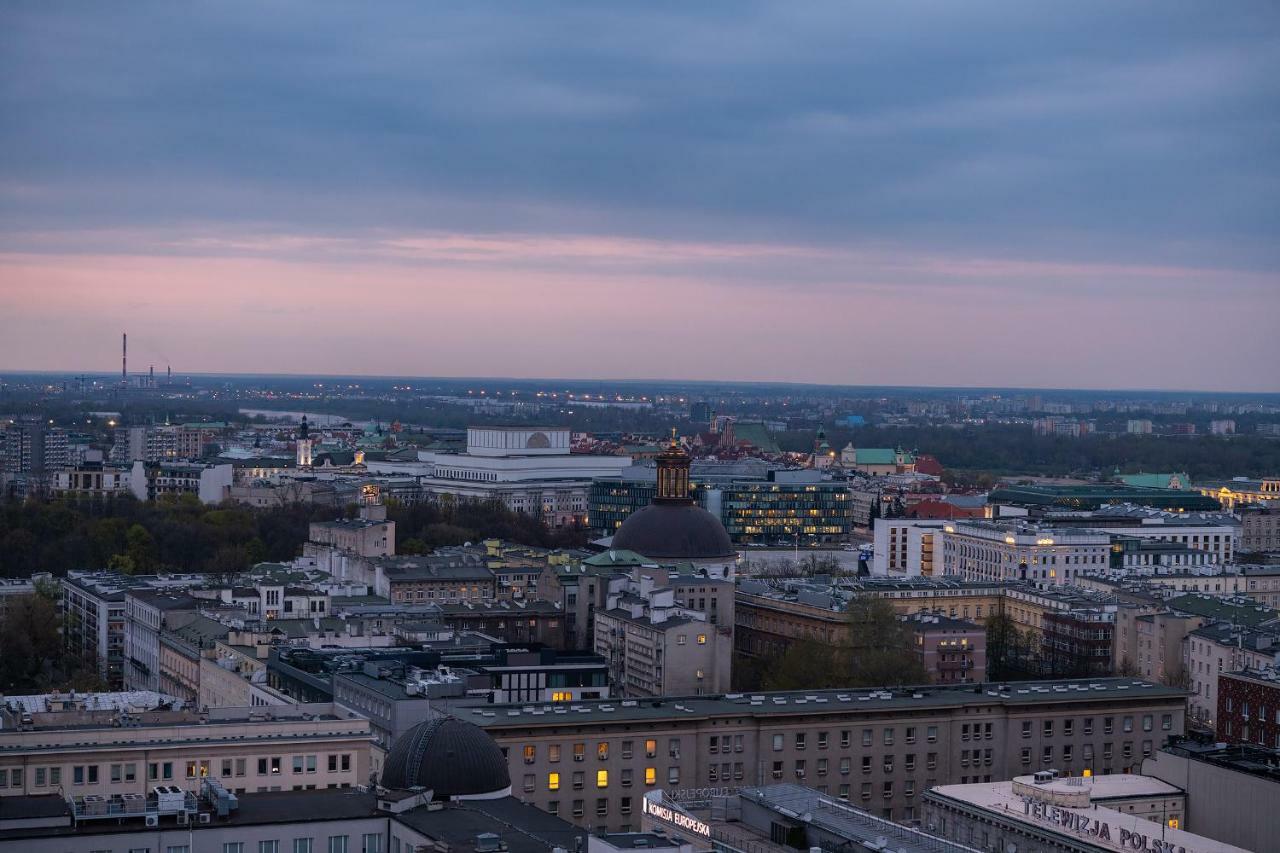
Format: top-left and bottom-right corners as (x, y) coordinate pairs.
(0, 704), (370, 797)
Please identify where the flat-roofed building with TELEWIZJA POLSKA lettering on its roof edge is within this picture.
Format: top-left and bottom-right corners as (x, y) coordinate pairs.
(924, 771), (1247, 853)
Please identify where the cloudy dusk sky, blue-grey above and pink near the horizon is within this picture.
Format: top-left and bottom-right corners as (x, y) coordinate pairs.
(0, 0), (1280, 392)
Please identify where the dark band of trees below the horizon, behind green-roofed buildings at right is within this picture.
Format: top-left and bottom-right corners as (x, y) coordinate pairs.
(783, 424), (1280, 482)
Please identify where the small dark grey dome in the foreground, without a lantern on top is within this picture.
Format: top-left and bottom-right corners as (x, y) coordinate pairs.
(383, 717), (511, 799)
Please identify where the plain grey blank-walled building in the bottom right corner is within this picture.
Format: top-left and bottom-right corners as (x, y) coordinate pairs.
(1142, 740), (1280, 852)
